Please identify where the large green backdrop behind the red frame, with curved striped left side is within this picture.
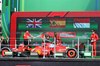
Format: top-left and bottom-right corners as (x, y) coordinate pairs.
(2, 0), (100, 37)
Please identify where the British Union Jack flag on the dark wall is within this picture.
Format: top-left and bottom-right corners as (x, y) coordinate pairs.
(26, 19), (42, 28)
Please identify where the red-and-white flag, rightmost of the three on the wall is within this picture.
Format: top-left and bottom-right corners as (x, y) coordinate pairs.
(73, 18), (90, 28)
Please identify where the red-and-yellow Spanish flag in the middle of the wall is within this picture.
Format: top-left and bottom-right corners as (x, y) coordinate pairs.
(50, 19), (66, 28)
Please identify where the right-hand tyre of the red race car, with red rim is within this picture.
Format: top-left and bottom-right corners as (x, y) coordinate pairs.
(64, 48), (77, 58)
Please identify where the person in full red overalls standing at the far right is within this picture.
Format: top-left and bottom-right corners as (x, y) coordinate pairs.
(90, 30), (99, 56)
